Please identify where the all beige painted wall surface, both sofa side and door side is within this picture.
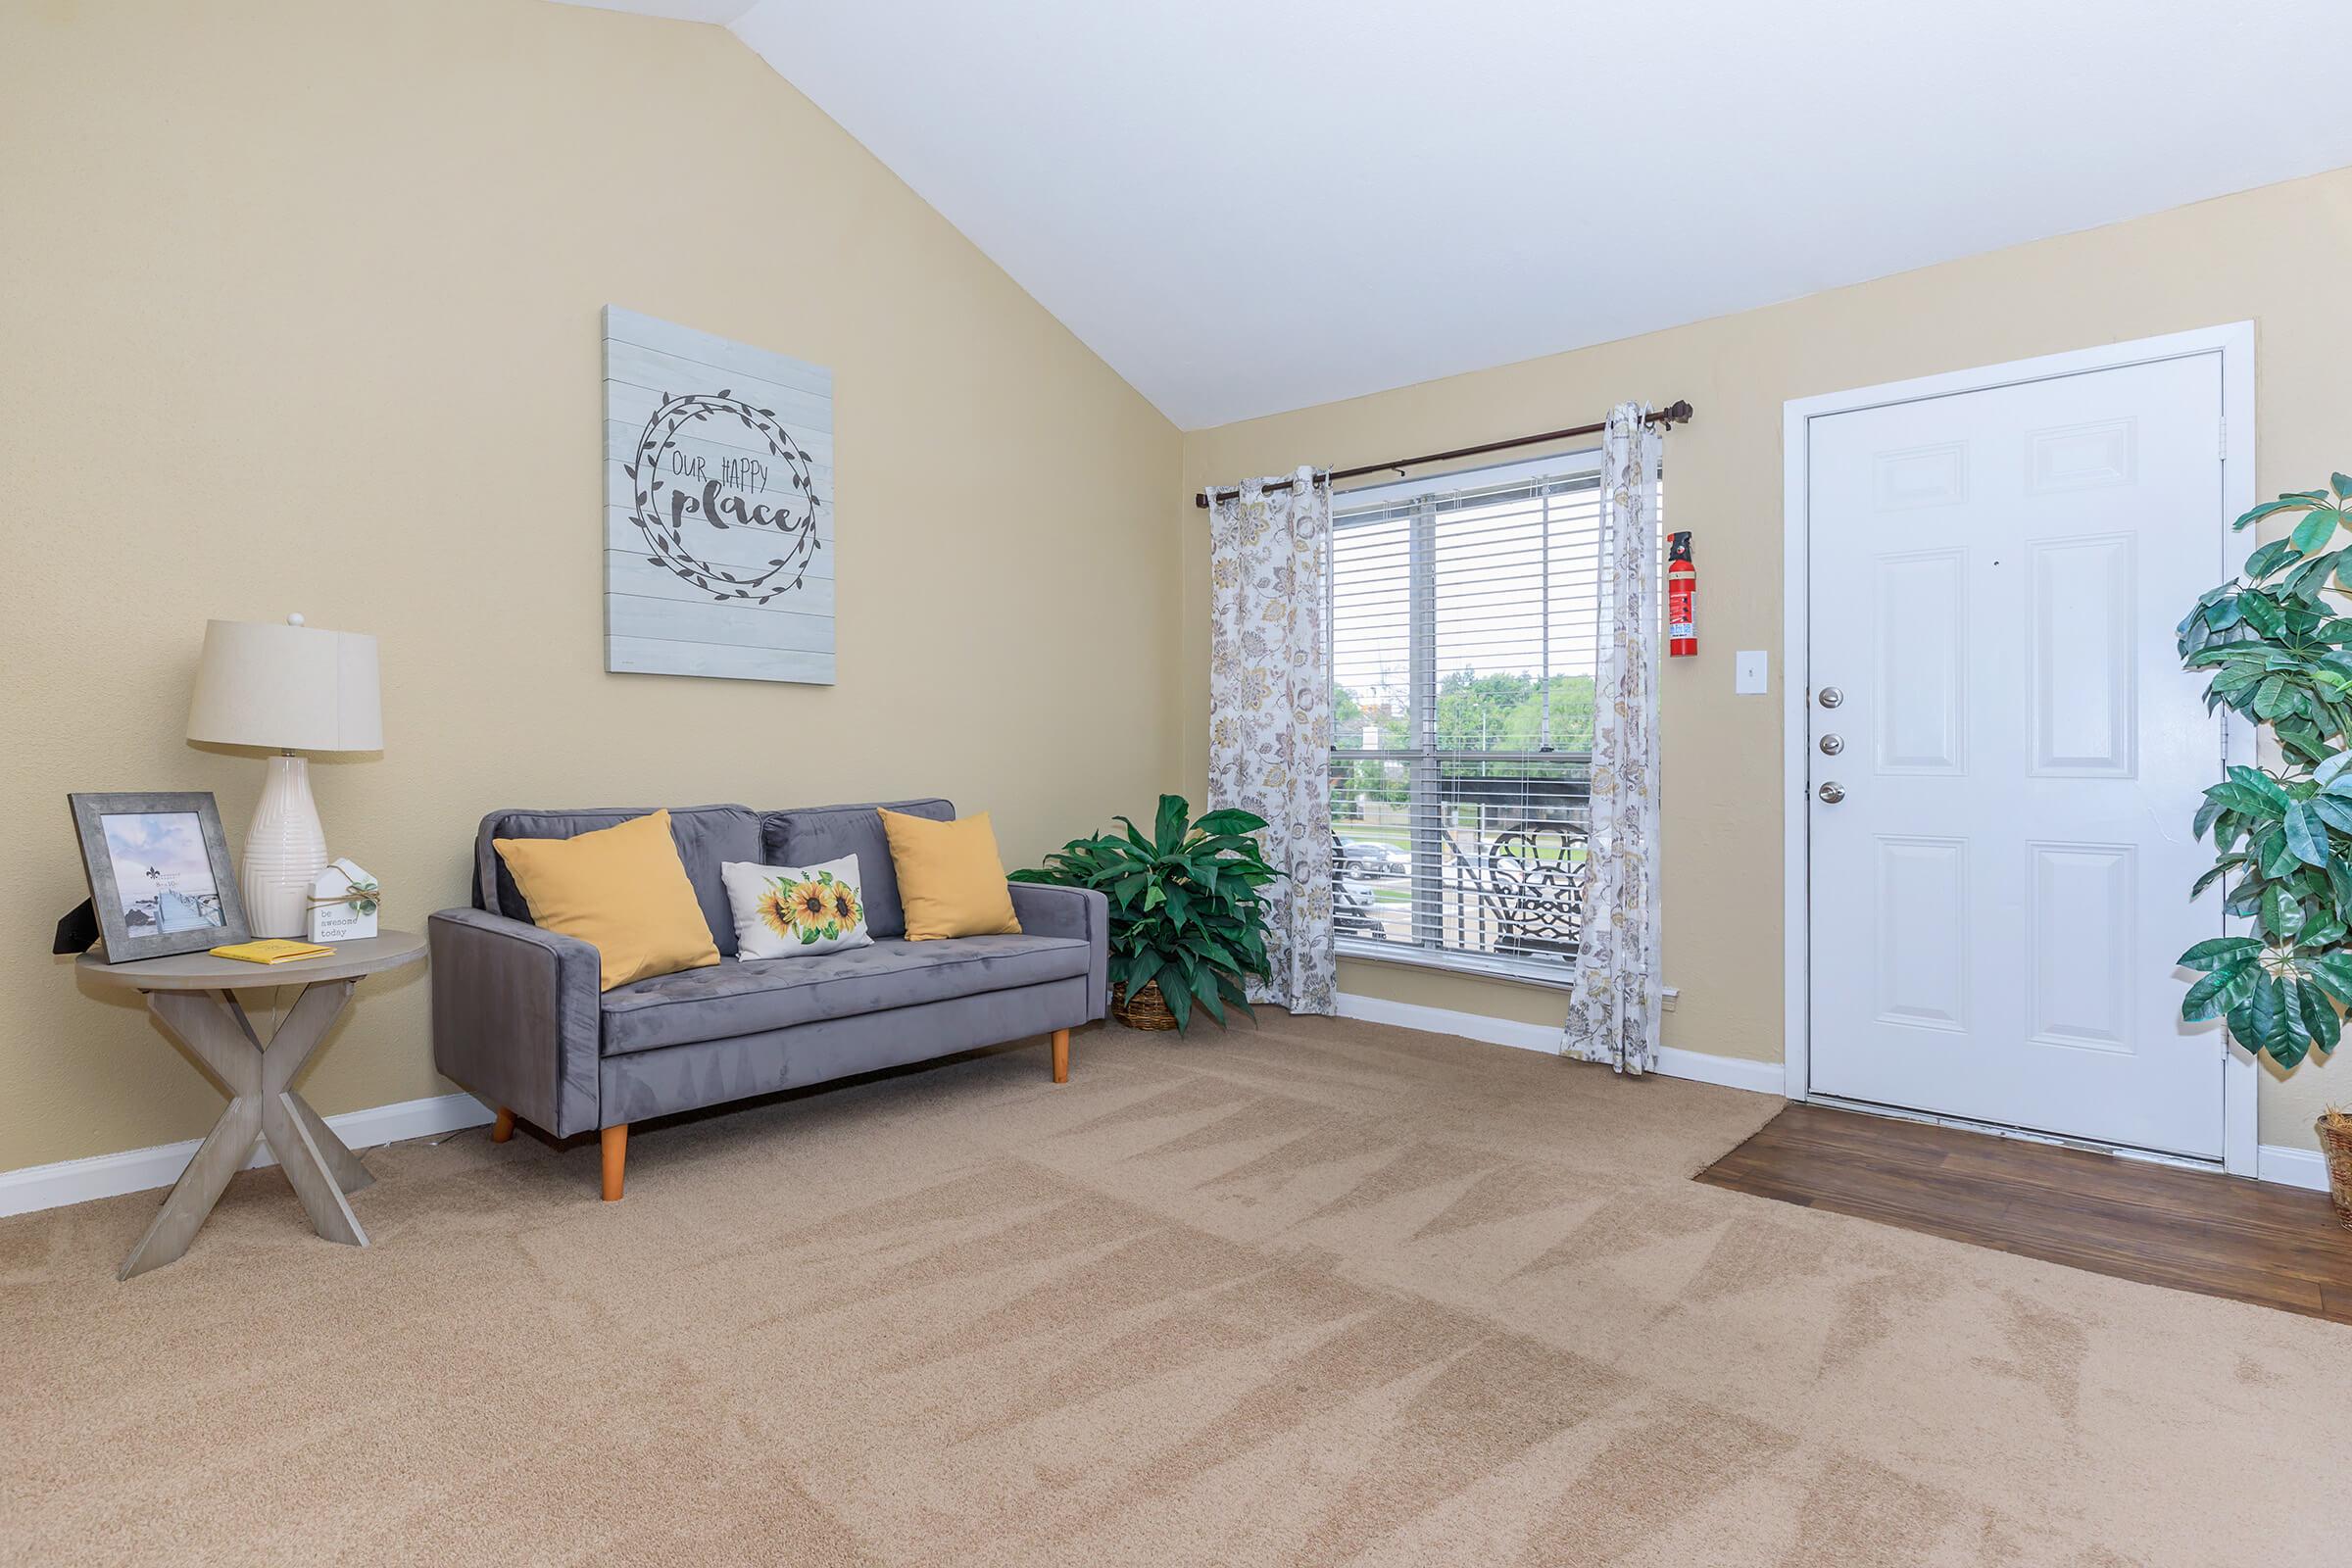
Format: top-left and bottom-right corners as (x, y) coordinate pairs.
(0, 0), (2352, 1171)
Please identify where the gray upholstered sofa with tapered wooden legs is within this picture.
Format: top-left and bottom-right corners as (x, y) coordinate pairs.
(425, 800), (1110, 1199)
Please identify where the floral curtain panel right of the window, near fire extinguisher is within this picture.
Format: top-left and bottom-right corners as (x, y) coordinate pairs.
(1559, 402), (1660, 1074)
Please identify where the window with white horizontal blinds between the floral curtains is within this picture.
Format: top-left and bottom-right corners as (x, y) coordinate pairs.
(1329, 454), (1655, 980)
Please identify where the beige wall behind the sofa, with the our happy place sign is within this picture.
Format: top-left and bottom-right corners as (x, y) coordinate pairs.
(0, 0), (1181, 1168)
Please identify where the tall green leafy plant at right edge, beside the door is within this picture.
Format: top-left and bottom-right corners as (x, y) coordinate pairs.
(2180, 475), (2352, 1067)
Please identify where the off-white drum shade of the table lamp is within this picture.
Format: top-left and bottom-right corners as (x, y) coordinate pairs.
(188, 620), (383, 753)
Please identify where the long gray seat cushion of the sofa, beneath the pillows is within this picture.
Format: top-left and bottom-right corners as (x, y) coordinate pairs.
(605, 936), (1094, 1055)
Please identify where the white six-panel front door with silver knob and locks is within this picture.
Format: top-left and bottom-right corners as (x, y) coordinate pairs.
(1806, 350), (2251, 1159)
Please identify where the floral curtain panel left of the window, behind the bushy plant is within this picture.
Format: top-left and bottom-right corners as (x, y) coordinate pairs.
(1209, 467), (1339, 1013)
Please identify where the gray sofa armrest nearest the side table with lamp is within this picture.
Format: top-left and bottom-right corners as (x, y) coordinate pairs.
(425, 909), (605, 1138)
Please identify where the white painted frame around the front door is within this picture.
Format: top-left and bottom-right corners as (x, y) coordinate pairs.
(1781, 322), (2260, 1175)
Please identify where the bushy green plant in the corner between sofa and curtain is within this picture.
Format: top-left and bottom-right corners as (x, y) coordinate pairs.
(1013, 795), (1282, 1030)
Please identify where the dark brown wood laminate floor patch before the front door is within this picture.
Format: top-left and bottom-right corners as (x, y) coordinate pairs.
(1698, 1104), (2352, 1324)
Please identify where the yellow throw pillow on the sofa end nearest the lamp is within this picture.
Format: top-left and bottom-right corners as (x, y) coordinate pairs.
(489, 811), (719, 990)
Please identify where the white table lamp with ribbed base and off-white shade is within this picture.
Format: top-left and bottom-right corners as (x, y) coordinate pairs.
(188, 615), (383, 936)
